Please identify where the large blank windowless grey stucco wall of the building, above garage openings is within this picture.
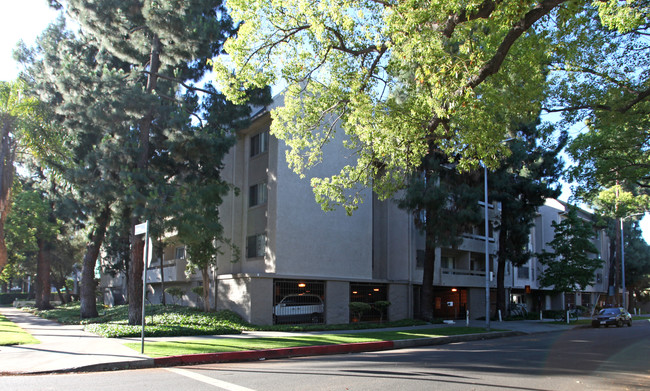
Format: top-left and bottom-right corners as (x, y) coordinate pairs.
(269, 136), (372, 279)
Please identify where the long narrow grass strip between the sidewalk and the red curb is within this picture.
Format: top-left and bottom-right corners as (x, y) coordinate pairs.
(125, 327), (485, 357)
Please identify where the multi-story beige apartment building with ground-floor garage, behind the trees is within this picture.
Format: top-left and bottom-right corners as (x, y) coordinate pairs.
(98, 97), (607, 324)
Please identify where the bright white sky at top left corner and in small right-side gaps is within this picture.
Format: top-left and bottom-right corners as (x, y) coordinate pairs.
(0, 0), (650, 243)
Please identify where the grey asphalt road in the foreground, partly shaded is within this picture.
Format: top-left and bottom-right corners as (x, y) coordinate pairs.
(5, 321), (650, 391)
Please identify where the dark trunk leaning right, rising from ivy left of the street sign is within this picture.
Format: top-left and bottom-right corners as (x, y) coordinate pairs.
(79, 204), (111, 319)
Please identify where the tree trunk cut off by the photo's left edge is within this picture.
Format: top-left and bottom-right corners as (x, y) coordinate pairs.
(0, 114), (16, 272)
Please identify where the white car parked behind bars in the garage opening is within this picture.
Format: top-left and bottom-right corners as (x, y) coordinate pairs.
(273, 294), (325, 323)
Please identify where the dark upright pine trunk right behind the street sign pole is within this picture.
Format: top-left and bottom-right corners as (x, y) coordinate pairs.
(128, 36), (161, 326)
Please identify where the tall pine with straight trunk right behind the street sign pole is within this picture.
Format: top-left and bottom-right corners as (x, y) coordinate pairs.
(60, 0), (238, 324)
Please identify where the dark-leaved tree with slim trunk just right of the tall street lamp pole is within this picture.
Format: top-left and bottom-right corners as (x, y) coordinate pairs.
(488, 123), (567, 314)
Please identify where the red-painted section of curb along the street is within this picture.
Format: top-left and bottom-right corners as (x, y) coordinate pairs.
(153, 341), (394, 367)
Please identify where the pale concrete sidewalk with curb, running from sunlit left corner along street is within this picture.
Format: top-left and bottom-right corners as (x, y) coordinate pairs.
(0, 307), (574, 375)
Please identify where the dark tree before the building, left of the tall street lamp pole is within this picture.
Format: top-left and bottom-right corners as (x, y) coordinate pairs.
(398, 149), (482, 321)
